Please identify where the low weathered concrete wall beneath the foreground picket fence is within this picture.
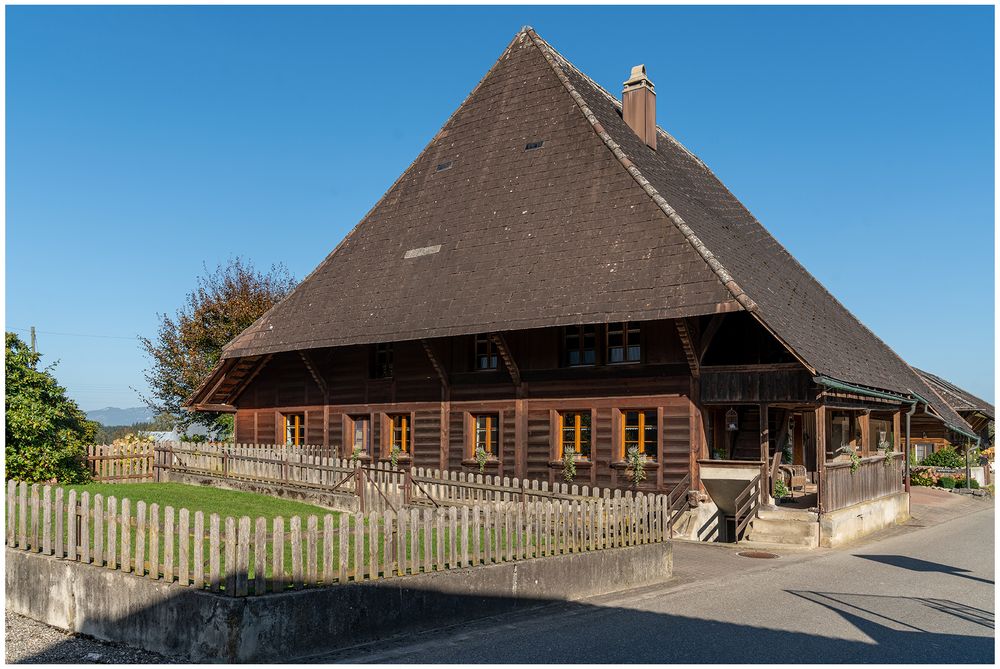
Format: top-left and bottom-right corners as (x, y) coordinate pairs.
(6, 543), (673, 662)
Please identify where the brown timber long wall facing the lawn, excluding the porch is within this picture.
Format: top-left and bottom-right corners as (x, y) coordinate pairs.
(233, 321), (703, 490)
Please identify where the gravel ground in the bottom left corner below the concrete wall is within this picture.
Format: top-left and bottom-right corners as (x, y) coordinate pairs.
(4, 612), (176, 664)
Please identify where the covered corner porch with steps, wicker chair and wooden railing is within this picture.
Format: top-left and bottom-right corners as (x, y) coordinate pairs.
(699, 365), (908, 546)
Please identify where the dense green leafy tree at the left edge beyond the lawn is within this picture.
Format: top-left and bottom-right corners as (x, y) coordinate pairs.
(4, 332), (97, 483)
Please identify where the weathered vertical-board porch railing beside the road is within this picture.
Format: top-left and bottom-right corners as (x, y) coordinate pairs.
(821, 453), (903, 512)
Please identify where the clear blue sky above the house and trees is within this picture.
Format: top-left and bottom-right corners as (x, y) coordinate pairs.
(6, 6), (994, 409)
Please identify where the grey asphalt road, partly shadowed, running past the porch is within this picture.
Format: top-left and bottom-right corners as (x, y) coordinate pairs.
(320, 503), (994, 664)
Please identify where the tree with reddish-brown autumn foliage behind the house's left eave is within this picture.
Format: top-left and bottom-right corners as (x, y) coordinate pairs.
(139, 257), (296, 436)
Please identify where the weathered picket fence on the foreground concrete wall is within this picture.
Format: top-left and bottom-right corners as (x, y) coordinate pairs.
(6, 481), (670, 597)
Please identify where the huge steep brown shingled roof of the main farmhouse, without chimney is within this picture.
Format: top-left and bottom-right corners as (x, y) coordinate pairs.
(205, 28), (969, 430)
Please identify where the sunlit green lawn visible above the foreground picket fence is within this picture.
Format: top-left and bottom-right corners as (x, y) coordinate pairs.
(53, 483), (337, 526)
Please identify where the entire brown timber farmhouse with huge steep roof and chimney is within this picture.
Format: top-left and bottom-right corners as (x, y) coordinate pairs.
(189, 28), (974, 544)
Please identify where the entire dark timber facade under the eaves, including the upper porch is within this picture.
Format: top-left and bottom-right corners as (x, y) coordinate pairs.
(223, 313), (916, 504)
